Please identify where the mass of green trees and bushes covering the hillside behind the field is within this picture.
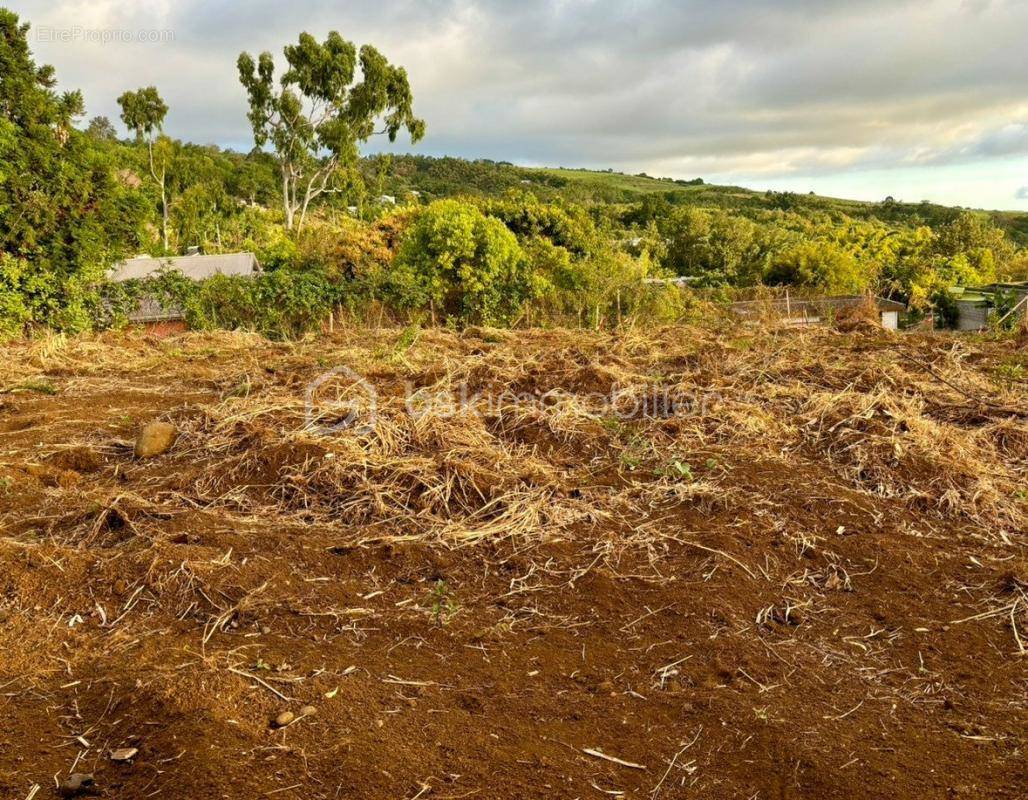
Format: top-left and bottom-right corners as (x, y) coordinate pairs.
(0, 10), (1028, 337)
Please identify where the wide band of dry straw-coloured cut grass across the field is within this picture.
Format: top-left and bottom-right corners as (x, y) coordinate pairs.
(12, 320), (1028, 545)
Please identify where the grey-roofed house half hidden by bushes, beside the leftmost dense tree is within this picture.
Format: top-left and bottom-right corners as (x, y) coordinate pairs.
(108, 253), (260, 325)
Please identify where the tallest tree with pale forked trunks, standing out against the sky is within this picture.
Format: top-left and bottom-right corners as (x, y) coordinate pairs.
(237, 31), (425, 230)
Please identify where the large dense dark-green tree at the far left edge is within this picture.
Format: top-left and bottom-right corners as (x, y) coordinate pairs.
(0, 8), (141, 335)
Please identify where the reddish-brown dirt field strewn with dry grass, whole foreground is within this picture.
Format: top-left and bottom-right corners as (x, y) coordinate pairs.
(0, 320), (1028, 800)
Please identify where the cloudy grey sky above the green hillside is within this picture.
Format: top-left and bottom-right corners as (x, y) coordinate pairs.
(8, 0), (1028, 210)
